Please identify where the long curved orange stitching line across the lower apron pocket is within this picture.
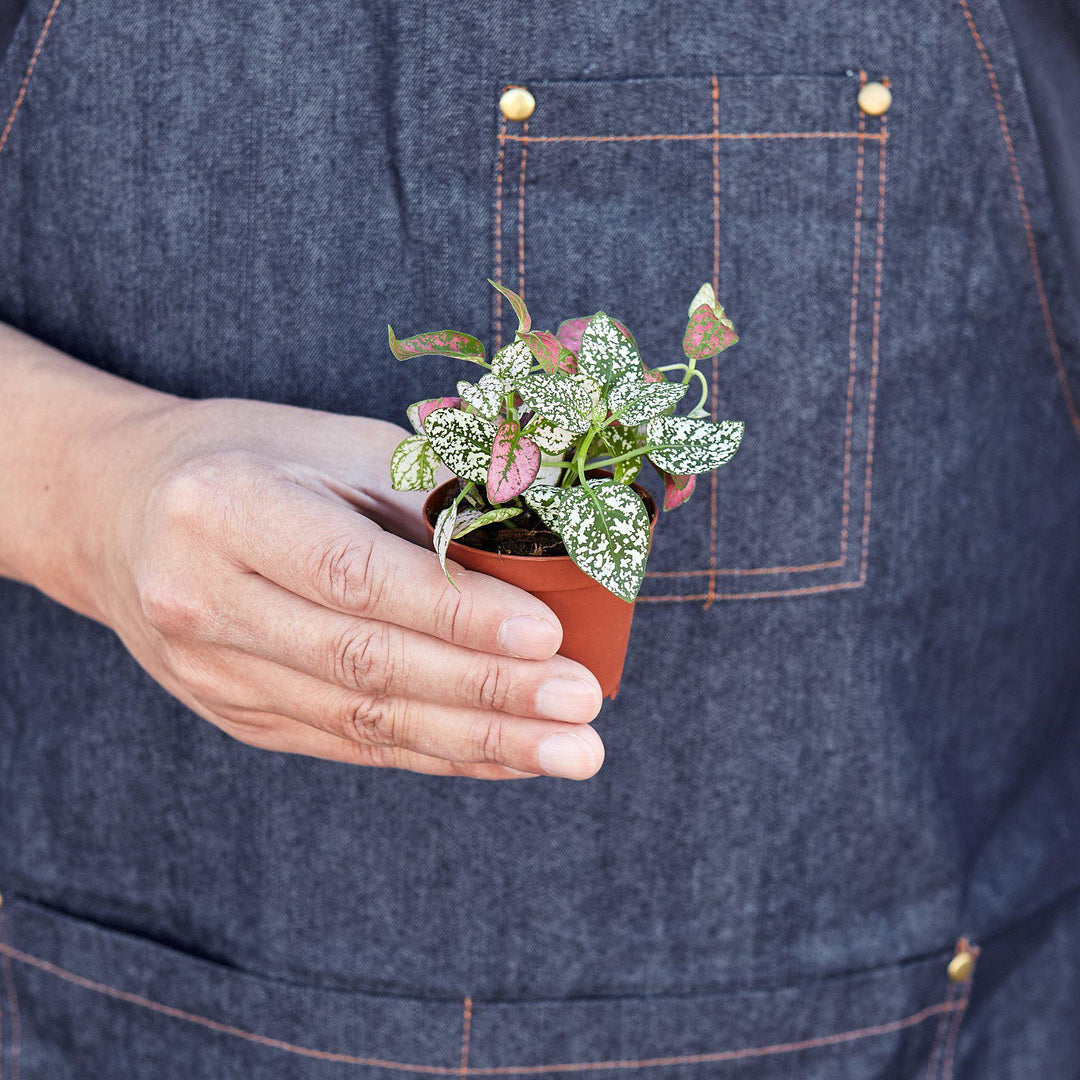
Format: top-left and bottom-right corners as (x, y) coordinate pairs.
(0, 943), (962, 1076)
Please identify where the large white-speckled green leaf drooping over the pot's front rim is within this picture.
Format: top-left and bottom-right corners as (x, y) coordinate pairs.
(525, 480), (649, 603)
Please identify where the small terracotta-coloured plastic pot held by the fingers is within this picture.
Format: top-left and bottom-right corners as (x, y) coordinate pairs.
(423, 480), (657, 698)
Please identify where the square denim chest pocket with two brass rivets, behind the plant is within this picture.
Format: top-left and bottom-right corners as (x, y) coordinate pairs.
(492, 72), (887, 602)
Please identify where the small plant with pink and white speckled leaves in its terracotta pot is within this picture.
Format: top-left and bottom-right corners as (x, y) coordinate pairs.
(388, 282), (743, 698)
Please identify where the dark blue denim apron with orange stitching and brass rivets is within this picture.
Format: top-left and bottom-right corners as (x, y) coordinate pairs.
(0, 0), (1080, 1080)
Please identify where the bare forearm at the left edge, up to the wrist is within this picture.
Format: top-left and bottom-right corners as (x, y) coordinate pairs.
(0, 324), (175, 615)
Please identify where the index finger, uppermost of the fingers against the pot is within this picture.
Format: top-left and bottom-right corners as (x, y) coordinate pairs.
(227, 481), (563, 660)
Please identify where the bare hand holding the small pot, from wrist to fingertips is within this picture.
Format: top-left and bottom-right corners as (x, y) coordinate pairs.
(69, 395), (604, 780)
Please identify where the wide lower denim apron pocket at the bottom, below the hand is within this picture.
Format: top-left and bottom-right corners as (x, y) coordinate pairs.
(0, 895), (971, 1080)
